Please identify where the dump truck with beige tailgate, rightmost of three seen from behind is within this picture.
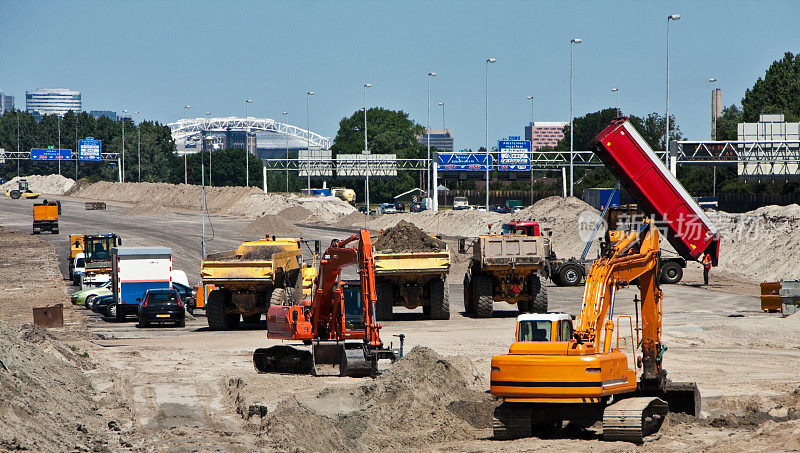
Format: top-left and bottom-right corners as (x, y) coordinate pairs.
(459, 233), (550, 318)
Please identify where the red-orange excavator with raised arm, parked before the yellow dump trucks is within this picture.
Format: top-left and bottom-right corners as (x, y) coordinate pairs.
(253, 230), (398, 377)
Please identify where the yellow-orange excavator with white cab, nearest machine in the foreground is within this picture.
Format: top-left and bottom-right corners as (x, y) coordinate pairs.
(491, 220), (700, 443)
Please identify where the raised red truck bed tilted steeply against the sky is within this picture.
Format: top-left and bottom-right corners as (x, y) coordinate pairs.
(589, 117), (719, 266)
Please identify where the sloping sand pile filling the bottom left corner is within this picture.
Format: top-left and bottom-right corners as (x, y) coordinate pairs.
(0, 322), (114, 451)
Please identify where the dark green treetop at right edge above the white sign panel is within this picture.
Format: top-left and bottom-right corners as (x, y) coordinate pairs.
(742, 52), (800, 122)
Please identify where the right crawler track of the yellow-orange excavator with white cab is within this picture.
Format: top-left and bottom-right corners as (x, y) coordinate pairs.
(603, 397), (669, 444)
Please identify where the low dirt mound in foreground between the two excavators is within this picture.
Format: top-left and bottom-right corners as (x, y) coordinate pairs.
(261, 347), (494, 451)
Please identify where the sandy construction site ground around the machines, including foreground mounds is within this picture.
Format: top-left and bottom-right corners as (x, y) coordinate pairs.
(0, 192), (800, 451)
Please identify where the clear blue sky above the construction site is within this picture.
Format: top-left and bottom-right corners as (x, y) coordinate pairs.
(0, 0), (800, 148)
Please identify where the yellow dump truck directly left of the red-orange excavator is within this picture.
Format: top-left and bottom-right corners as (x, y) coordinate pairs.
(198, 237), (319, 330)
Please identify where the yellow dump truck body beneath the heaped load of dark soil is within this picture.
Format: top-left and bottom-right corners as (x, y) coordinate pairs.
(372, 248), (450, 321)
